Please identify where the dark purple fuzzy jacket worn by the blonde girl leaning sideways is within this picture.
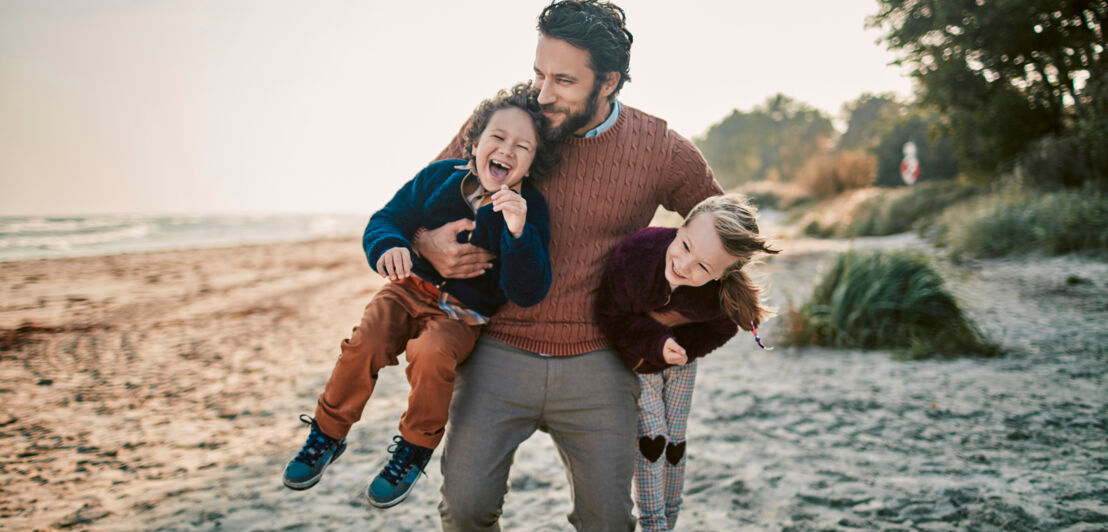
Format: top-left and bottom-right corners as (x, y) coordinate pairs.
(597, 227), (739, 374)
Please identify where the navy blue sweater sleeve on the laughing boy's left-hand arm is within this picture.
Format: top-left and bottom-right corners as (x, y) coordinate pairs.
(361, 161), (458, 270)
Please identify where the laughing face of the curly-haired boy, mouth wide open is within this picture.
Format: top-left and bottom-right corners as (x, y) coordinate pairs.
(473, 108), (538, 192)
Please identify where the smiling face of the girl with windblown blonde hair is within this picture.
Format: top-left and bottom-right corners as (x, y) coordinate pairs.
(666, 213), (738, 288)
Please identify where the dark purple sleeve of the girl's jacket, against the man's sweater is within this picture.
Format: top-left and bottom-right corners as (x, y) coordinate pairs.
(597, 235), (674, 374)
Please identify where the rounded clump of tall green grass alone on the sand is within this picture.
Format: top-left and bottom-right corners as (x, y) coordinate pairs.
(786, 252), (999, 358)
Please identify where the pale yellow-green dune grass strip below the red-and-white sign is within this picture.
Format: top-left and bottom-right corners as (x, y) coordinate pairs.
(833, 181), (983, 237)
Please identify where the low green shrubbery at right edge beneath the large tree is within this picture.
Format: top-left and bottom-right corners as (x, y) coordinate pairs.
(936, 187), (1108, 257)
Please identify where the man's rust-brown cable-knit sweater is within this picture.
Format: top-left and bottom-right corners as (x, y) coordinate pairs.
(439, 105), (722, 356)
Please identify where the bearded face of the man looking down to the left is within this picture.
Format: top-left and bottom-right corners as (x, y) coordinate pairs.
(534, 35), (614, 137)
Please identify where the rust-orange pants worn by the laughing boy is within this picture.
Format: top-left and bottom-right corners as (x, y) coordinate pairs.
(316, 283), (481, 449)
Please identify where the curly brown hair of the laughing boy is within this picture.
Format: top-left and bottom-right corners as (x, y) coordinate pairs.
(462, 81), (560, 180)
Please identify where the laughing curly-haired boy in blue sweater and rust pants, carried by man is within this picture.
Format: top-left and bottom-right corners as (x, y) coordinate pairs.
(284, 83), (557, 508)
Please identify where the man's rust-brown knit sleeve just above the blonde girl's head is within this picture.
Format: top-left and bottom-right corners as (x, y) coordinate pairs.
(660, 131), (724, 216)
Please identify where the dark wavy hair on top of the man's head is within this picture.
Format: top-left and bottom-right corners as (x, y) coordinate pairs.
(538, 0), (635, 102)
